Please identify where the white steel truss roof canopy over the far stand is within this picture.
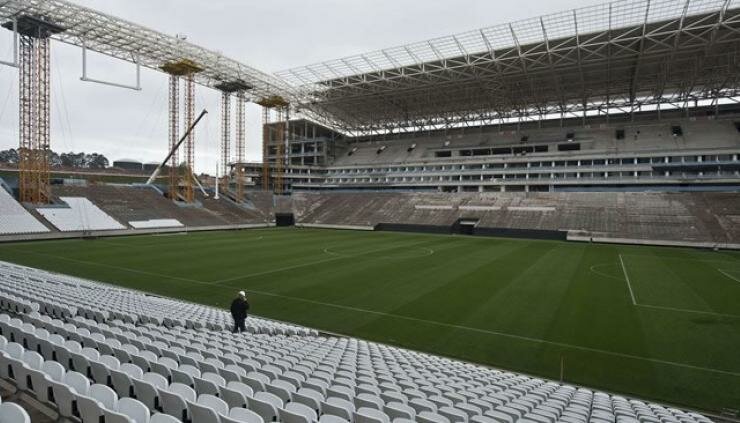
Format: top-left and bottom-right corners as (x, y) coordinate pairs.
(277, 0), (740, 135)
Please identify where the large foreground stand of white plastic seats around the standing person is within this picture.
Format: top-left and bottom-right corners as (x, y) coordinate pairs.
(0, 263), (710, 423)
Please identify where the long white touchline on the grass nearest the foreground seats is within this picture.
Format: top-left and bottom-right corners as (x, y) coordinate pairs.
(5, 251), (740, 377)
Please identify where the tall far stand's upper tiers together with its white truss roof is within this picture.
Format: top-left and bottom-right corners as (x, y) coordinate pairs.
(244, 0), (740, 192)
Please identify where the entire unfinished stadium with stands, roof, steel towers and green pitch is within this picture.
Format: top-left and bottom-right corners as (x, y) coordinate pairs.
(0, 0), (740, 423)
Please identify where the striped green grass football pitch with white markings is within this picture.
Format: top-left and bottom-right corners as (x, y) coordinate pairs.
(0, 229), (740, 411)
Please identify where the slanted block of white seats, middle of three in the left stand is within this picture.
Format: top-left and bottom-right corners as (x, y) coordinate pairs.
(36, 197), (126, 232)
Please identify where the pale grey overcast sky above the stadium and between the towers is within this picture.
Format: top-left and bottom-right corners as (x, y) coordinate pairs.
(0, 0), (588, 173)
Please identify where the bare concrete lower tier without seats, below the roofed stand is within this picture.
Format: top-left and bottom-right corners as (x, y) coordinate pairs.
(293, 192), (740, 243)
